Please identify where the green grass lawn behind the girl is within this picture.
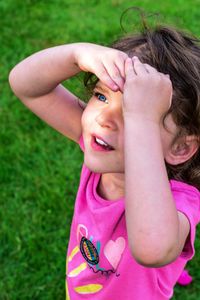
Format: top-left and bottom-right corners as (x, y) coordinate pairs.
(0, 0), (200, 300)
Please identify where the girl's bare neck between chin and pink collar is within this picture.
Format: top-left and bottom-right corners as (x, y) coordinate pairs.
(98, 173), (125, 200)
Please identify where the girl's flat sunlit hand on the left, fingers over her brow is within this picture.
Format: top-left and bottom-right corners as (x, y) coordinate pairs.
(75, 43), (128, 91)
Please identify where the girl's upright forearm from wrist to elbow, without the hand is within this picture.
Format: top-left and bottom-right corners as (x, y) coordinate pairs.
(125, 116), (179, 263)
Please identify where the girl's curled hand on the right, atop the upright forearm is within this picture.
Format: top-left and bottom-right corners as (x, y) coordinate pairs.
(123, 57), (172, 123)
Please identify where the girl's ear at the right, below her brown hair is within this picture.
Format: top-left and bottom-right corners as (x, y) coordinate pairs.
(165, 135), (199, 165)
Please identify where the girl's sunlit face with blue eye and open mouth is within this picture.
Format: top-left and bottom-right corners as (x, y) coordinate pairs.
(82, 81), (177, 174)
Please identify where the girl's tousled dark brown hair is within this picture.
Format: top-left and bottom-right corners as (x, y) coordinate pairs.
(85, 26), (200, 189)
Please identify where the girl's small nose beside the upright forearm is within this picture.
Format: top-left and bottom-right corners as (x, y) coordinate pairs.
(95, 107), (122, 130)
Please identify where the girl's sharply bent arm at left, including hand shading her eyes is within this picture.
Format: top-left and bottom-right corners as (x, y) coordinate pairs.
(9, 43), (126, 142)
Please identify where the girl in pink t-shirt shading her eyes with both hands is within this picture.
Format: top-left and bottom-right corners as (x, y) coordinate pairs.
(9, 22), (200, 300)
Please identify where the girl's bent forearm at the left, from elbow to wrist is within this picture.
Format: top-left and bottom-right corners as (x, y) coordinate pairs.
(9, 44), (81, 98)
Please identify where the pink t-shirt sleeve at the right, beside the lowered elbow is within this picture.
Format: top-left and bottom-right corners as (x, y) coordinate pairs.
(170, 180), (200, 260)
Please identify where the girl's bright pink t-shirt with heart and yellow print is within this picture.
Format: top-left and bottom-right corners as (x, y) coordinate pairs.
(66, 139), (200, 300)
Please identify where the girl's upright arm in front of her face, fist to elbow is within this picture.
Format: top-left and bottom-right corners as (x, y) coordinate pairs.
(124, 56), (189, 267)
